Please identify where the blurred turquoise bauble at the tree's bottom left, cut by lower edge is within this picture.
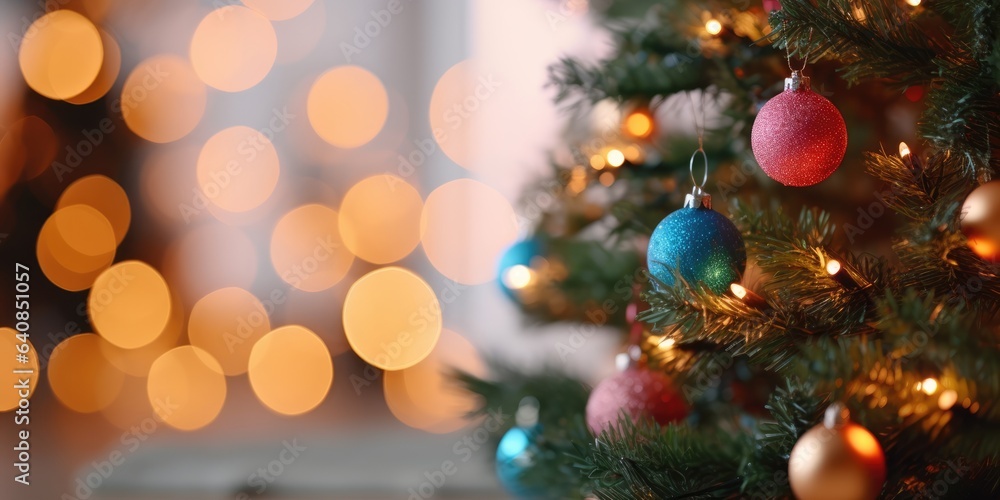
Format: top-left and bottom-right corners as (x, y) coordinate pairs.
(497, 397), (545, 499)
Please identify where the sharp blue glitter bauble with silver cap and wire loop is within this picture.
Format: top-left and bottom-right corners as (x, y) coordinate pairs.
(646, 188), (747, 294)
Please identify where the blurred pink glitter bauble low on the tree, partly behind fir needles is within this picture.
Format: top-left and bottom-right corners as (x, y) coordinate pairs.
(587, 368), (688, 434)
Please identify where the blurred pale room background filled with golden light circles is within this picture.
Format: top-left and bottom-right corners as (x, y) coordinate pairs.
(0, 0), (919, 500)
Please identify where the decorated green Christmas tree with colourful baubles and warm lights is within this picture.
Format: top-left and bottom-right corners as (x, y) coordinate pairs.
(460, 0), (1000, 499)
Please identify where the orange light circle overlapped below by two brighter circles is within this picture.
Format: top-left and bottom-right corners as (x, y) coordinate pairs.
(188, 287), (271, 376)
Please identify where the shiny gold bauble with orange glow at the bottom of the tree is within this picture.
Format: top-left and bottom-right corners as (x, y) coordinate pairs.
(788, 404), (885, 500)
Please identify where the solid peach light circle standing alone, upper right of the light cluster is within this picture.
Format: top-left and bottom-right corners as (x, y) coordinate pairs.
(306, 66), (389, 148)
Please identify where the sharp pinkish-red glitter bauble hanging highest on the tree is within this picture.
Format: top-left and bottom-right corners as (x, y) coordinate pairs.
(750, 71), (847, 186)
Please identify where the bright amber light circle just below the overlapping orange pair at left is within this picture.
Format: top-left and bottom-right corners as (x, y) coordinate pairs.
(87, 260), (173, 349)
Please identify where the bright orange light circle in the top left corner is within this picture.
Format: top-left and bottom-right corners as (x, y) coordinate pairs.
(18, 10), (104, 99)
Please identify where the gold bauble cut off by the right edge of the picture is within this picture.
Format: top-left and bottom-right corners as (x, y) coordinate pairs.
(959, 181), (1000, 262)
